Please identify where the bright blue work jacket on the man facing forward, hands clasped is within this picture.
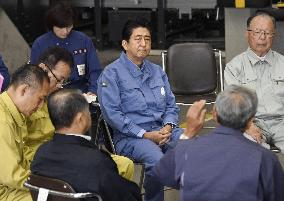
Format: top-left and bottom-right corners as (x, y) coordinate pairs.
(98, 52), (179, 141)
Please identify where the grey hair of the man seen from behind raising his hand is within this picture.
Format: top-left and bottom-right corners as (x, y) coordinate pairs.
(215, 85), (258, 129)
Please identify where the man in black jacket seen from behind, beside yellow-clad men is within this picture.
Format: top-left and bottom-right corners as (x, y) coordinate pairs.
(31, 89), (141, 201)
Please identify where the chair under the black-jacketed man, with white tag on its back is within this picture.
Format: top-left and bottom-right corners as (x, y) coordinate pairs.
(24, 174), (102, 201)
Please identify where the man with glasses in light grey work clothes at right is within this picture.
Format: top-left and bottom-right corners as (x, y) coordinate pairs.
(224, 12), (284, 153)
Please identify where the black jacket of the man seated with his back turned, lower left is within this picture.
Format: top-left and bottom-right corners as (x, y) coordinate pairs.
(31, 134), (141, 201)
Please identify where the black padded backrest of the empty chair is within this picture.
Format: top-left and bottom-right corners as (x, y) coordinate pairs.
(166, 43), (218, 95)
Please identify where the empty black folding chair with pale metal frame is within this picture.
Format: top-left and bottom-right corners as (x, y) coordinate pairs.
(162, 43), (224, 105)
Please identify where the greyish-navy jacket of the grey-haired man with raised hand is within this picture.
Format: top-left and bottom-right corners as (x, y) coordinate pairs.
(154, 126), (284, 201)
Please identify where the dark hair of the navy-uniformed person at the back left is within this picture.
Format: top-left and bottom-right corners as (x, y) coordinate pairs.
(45, 2), (75, 30)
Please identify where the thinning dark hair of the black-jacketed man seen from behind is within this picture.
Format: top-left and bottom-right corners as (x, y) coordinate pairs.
(47, 89), (89, 130)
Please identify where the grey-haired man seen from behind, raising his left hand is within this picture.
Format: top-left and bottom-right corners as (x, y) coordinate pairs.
(153, 85), (284, 201)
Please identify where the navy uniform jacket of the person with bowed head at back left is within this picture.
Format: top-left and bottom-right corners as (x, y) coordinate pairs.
(30, 30), (102, 93)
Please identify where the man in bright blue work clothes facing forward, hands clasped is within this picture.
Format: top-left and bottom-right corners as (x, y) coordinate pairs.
(98, 18), (183, 201)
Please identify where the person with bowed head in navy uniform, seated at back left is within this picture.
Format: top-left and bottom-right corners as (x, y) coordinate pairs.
(30, 3), (102, 95)
